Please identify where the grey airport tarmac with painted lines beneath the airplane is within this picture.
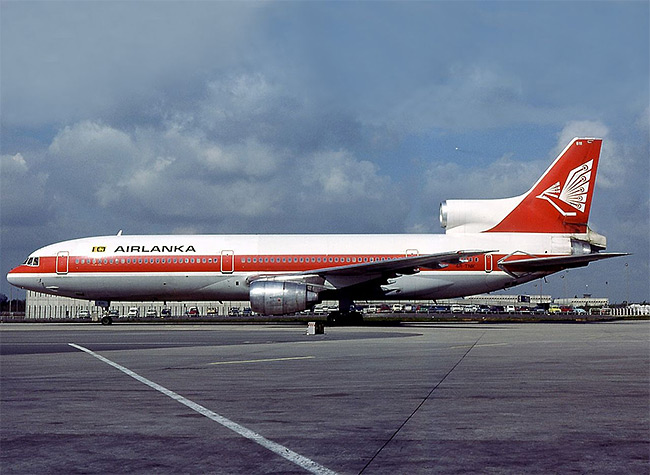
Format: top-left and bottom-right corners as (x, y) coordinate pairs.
(0, 321), (650, 474)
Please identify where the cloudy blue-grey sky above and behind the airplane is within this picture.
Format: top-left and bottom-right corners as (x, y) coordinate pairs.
(0, 1), (650, 302)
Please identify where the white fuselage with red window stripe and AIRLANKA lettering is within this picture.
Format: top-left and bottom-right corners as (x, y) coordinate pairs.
(8, 233), (576, 300)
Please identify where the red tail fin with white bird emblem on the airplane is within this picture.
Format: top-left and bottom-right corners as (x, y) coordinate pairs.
(487, 138), (602, 233)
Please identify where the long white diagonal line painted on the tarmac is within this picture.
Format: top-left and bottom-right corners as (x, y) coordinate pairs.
(68, 343), (336, 475)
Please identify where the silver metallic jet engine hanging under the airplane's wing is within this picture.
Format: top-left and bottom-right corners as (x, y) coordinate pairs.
(250, 280), (320, 315)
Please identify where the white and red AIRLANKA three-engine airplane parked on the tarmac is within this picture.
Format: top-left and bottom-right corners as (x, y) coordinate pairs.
(7, 138), (626, 323)
